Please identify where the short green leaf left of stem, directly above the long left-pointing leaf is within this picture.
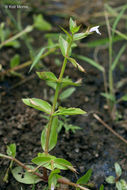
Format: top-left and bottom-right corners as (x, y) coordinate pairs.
(36, 72), (57, 82)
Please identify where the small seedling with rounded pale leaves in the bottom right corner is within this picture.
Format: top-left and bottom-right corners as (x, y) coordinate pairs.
(106, 162), (127, 190)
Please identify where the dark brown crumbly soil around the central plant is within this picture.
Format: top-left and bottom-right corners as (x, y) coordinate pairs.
(0, 0), (127, 190)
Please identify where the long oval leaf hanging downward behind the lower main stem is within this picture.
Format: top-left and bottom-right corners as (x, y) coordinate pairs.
(41, 117), (58, 151)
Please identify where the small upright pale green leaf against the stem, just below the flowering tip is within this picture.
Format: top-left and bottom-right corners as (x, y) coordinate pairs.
(59, 36), (68, 57)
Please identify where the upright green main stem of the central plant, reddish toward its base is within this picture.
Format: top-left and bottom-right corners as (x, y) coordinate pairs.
(45, 36), (73, 154)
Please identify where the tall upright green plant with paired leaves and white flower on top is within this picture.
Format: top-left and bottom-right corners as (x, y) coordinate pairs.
(0, 19), (103, 190)
